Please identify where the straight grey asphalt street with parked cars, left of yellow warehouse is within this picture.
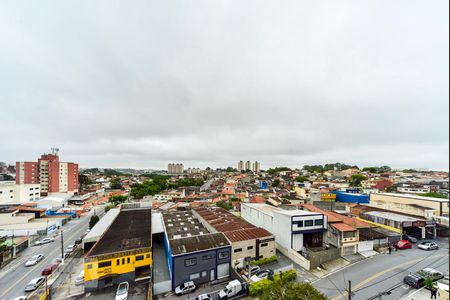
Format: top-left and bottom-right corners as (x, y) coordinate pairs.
(0, 212), (97, 300)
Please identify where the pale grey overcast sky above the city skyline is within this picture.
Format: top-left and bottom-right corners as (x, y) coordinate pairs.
(0, 0), (449, 170)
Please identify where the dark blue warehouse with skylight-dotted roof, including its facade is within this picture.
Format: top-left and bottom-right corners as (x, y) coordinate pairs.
(162, 210), (231, 290)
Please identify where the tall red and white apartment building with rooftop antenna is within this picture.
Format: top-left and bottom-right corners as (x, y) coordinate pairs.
(16, 151), (78, 196)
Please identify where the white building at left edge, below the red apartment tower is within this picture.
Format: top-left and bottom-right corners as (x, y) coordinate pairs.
(0, 181), (40, 204)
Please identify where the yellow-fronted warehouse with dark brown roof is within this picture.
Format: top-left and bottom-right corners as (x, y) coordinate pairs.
(84, 207), (152, 291)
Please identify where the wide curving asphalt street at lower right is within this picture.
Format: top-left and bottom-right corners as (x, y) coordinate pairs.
(313, 239), (449, 300)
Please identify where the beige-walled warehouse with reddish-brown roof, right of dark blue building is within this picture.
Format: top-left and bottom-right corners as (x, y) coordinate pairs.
(193, 207), (276, 264)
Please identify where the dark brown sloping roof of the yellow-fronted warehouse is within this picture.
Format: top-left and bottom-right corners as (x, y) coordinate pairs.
(87, 208), (152, 257)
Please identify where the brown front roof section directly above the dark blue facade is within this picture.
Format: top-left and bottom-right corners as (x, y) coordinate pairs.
(169, 232), (230, 255)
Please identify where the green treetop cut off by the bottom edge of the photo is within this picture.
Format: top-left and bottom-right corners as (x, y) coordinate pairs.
(259, 280), (328, 300)
